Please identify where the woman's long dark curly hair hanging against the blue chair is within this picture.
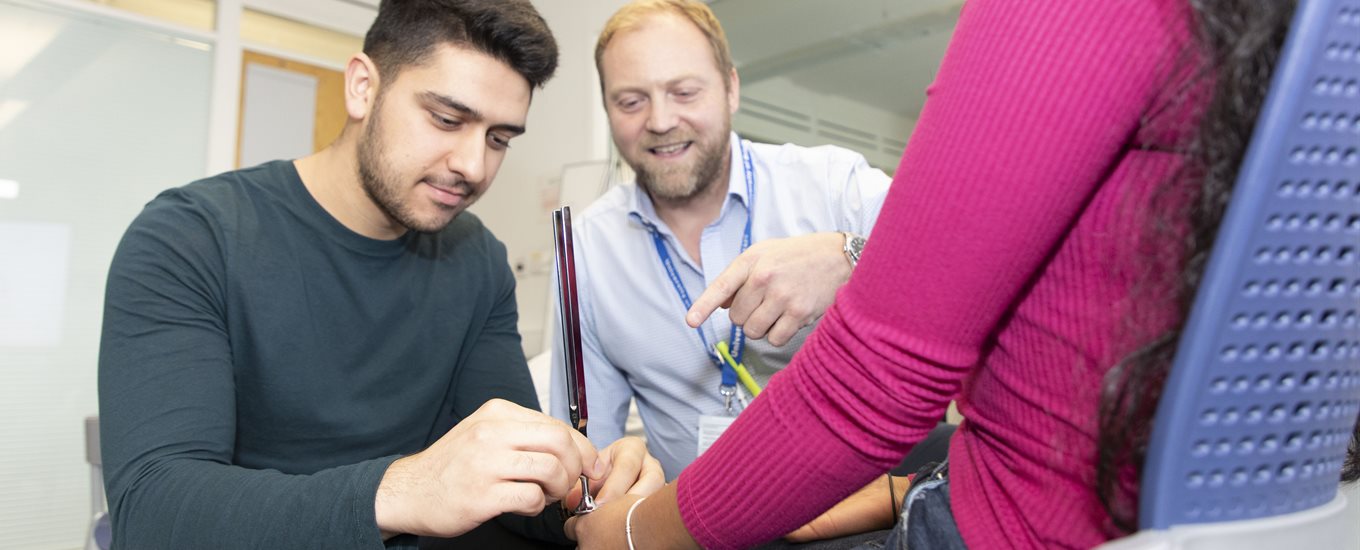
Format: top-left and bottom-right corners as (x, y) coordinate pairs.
(1096, 0), (1360, 532)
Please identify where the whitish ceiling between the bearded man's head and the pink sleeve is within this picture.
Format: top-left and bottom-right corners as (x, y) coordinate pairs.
(710, 0), (963, 118)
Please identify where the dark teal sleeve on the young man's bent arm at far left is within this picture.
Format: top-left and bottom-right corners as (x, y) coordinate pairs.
(99, 195), (402, 549)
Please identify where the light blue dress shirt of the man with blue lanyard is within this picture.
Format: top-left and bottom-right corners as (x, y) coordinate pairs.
(549, 133), (891, 481)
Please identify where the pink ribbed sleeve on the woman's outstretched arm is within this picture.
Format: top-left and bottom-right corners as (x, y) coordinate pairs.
(677, 0), (1183, 549)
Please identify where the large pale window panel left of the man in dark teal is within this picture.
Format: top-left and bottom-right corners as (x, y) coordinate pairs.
(0, 0), (212, 549)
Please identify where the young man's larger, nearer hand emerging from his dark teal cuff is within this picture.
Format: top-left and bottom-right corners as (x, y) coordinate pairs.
(374, 399), (608, 538)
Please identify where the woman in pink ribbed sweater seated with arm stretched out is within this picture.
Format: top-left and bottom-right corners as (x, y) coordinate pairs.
(577, 0), (1360, 549)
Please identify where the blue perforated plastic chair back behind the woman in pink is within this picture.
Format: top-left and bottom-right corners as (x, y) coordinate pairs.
(1104, 0), (1360, 550)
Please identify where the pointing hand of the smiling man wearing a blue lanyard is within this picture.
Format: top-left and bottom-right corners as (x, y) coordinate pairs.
(685, 233), (850, 346)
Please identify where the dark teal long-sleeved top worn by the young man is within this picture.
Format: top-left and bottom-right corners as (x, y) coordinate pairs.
(99, 162), (564, 549)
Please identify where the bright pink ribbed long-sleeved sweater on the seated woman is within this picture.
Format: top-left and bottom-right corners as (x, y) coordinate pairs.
(677, 0), (1190, 549)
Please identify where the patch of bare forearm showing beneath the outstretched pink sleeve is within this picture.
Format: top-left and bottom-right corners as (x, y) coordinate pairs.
(783, 475), (910, 542)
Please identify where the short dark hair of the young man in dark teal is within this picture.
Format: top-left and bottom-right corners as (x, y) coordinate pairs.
(363, 0), (558, 90)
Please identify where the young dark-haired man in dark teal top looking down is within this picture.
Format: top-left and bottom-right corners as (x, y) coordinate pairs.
(99, 0), (661, 549)
